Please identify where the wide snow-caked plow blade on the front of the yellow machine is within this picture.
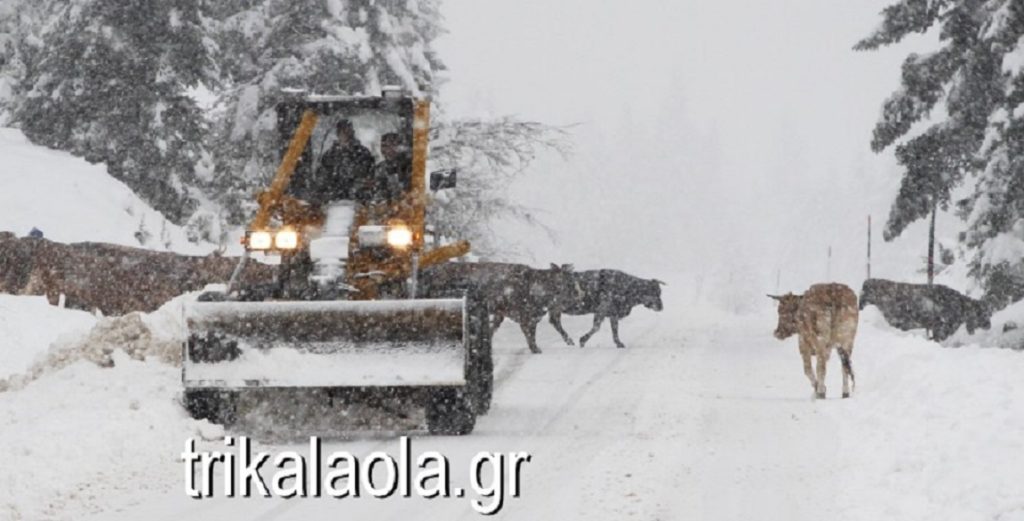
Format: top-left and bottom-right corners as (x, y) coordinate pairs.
(182, 299), (466, 389)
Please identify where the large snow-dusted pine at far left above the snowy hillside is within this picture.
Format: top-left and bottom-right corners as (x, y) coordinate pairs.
(14, 0), (212, 222)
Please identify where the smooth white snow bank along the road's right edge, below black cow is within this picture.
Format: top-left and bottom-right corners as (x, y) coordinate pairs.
(831, 308), (1024, 521)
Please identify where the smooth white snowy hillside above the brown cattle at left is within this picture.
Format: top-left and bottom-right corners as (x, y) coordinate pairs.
(0, 128), (214, 254)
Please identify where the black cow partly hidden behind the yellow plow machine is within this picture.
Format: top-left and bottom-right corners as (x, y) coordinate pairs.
(421, 262), (578, 353)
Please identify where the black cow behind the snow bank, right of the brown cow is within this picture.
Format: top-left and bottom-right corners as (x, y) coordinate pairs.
(860, 278), (992, 342)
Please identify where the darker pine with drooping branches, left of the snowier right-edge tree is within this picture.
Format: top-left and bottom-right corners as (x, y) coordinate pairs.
(855, 0), (1004, 241)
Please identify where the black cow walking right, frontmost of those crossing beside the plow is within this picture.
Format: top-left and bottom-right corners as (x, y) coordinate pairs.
(548, 269), (665, 348)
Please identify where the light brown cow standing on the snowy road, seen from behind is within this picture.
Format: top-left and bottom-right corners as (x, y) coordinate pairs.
(769, 284), (858, 398)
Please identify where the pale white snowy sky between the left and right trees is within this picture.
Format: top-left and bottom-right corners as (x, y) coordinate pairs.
(437, 0), (953, 298)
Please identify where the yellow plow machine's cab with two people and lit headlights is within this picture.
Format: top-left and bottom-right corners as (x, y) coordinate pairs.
(237, 91), (469, 300)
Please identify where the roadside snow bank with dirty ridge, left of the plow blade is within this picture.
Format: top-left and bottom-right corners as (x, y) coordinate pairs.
(0, 295), (205, 521)
